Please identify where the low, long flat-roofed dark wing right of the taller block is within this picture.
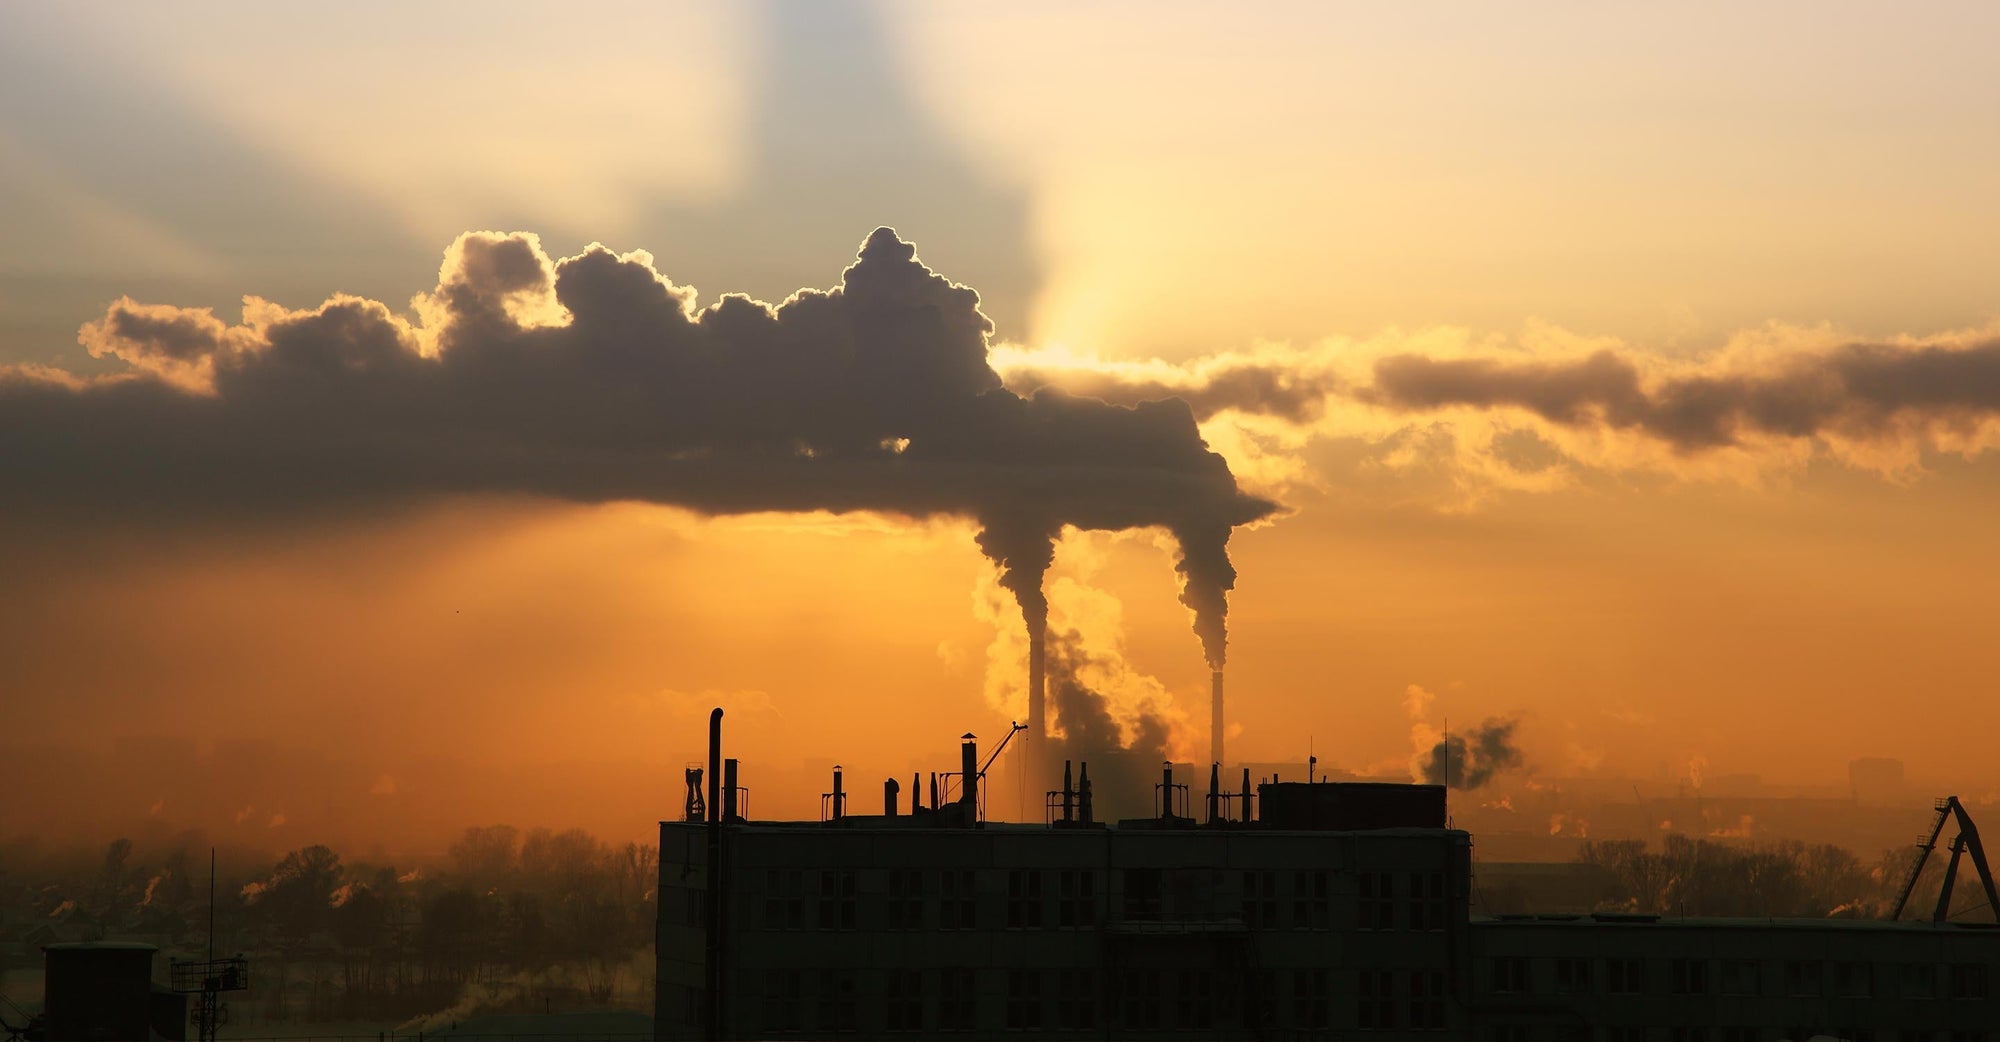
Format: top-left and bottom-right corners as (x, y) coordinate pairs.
(1468, 914), (2000, 1042)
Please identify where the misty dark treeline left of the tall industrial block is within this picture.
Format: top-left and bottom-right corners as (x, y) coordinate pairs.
(0, 826), (658, 1022)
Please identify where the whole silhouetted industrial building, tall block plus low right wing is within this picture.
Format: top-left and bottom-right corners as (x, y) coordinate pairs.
(654, 724), (2000, 1042)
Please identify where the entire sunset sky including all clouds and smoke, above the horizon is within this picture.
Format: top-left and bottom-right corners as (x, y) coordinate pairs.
(0, 2), (2000, 850)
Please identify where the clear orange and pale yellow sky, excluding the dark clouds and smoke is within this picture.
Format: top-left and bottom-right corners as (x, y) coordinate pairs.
(0, 4), (2000, 848)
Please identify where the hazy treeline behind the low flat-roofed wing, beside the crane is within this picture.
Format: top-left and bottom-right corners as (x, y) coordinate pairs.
(1578, 834), (1992, 918)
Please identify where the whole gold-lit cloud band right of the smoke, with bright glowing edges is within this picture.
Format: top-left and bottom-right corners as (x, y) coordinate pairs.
(996, 322), (2000, 506)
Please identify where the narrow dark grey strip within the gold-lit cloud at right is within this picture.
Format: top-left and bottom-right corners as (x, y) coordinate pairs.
(1358, 340), (2000, 452)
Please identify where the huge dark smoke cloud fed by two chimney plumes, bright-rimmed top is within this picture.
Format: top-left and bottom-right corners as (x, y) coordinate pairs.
(0, 228), (1272, 664)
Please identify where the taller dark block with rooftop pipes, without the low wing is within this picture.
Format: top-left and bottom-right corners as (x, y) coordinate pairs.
(654, 728), (1470, 1040)
